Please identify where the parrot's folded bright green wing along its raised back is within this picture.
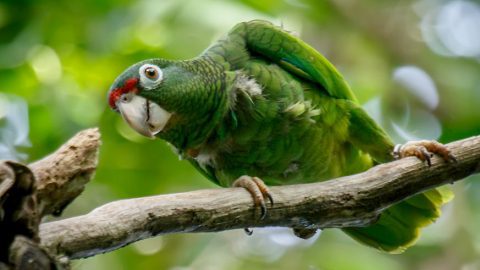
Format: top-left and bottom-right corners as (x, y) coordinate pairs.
(206, 20), (357, 103)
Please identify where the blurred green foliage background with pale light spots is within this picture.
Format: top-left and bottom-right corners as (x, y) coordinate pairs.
(0, 0), (480, 270)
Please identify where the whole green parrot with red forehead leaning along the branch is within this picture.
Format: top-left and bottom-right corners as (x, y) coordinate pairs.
(108, 20), (454, 253)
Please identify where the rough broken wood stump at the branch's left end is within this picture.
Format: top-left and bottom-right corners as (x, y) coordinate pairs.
(0, 129), (100, 270)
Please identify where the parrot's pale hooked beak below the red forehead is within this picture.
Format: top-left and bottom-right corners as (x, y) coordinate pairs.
(116, 93), (171, 138)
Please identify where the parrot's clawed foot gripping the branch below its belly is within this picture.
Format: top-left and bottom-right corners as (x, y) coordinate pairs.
(232, 175), (273, 219)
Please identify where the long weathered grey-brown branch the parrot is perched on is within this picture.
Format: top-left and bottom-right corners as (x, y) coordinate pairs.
(40, 136), (480, 258)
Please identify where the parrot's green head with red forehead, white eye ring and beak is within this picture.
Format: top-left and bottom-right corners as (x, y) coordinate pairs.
(108, 58), (229, 149)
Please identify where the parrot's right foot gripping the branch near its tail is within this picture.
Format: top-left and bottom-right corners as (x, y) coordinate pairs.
(393, 140), (457, 166)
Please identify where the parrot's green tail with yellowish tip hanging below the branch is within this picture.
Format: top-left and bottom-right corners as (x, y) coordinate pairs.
(343, 186), (453, 253)
